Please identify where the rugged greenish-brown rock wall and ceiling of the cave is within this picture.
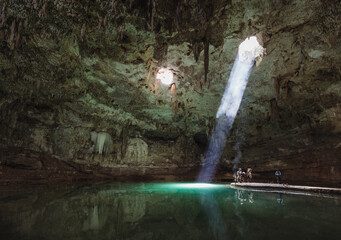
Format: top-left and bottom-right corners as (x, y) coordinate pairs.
(0, 0), (341, 185)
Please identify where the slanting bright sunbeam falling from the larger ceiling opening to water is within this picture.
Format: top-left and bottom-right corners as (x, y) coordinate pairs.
(198, 37), (263, 182)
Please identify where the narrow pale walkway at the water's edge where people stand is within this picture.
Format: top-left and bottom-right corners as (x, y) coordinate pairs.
(231, 182), (341, 194)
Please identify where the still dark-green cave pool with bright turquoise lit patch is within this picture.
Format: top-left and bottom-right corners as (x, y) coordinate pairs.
(0, 183), (341, 240)
